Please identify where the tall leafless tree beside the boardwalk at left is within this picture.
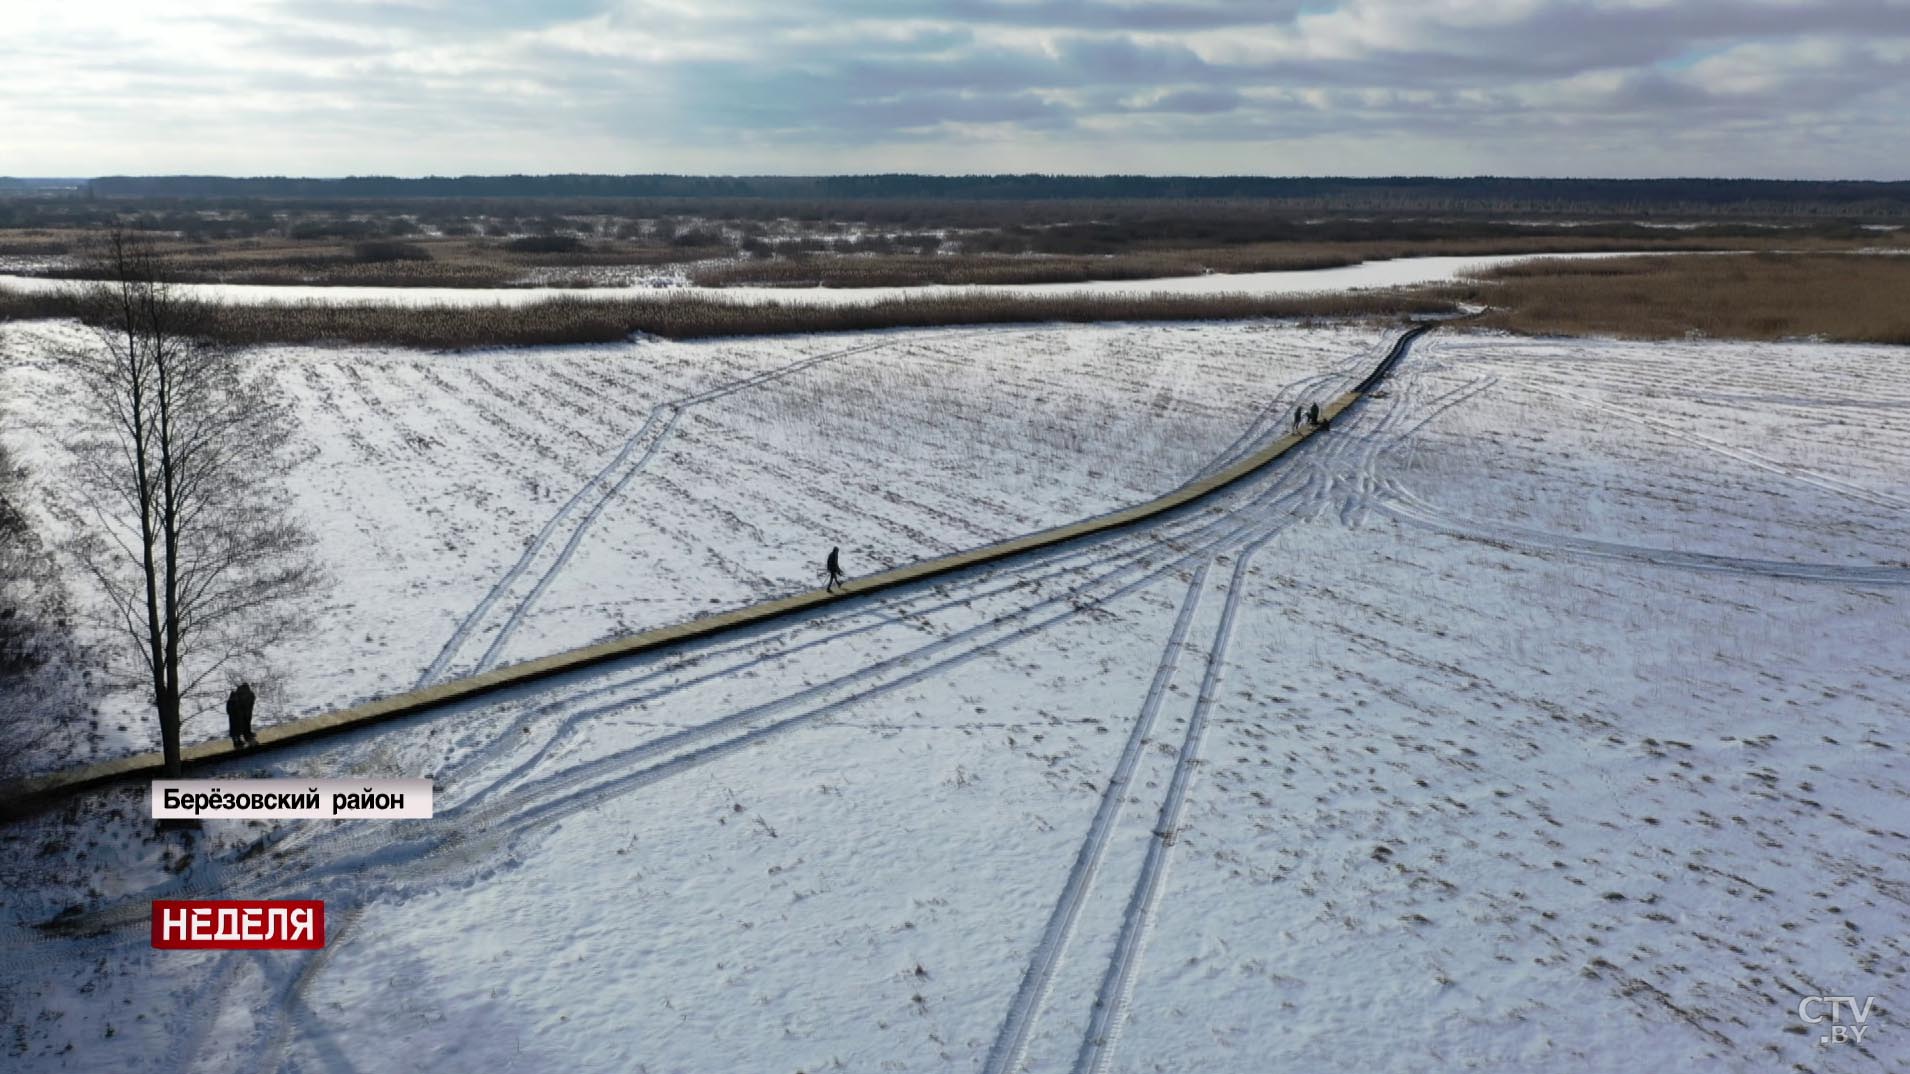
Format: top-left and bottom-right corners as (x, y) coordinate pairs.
(65, 231), (321, 776)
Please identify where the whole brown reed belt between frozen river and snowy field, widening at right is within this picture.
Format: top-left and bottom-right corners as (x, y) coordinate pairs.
(14, 252), (1910, 350)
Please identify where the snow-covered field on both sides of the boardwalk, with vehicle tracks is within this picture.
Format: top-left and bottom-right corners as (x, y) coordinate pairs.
(0, 327), (1910, 1072)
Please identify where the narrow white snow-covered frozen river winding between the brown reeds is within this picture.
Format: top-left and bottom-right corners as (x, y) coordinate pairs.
(0, 254), (1627, 306)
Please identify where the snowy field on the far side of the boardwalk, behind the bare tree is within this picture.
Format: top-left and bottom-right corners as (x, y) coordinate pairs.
(0, 323), (1387, 764)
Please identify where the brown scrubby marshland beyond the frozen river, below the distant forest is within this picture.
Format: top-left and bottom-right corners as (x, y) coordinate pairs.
(14, 201), (1910, 287)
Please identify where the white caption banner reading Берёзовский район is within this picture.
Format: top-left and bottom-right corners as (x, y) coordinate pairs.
(153, 780), (432, 820)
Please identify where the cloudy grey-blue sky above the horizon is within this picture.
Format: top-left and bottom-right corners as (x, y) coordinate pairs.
(0, 0), (1910, 180)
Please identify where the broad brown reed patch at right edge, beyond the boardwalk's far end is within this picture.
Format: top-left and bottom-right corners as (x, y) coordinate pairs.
(1440, 252), (1910, 344)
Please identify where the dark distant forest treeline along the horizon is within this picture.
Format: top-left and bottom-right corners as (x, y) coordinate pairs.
(67, 174), (1910, 218)
